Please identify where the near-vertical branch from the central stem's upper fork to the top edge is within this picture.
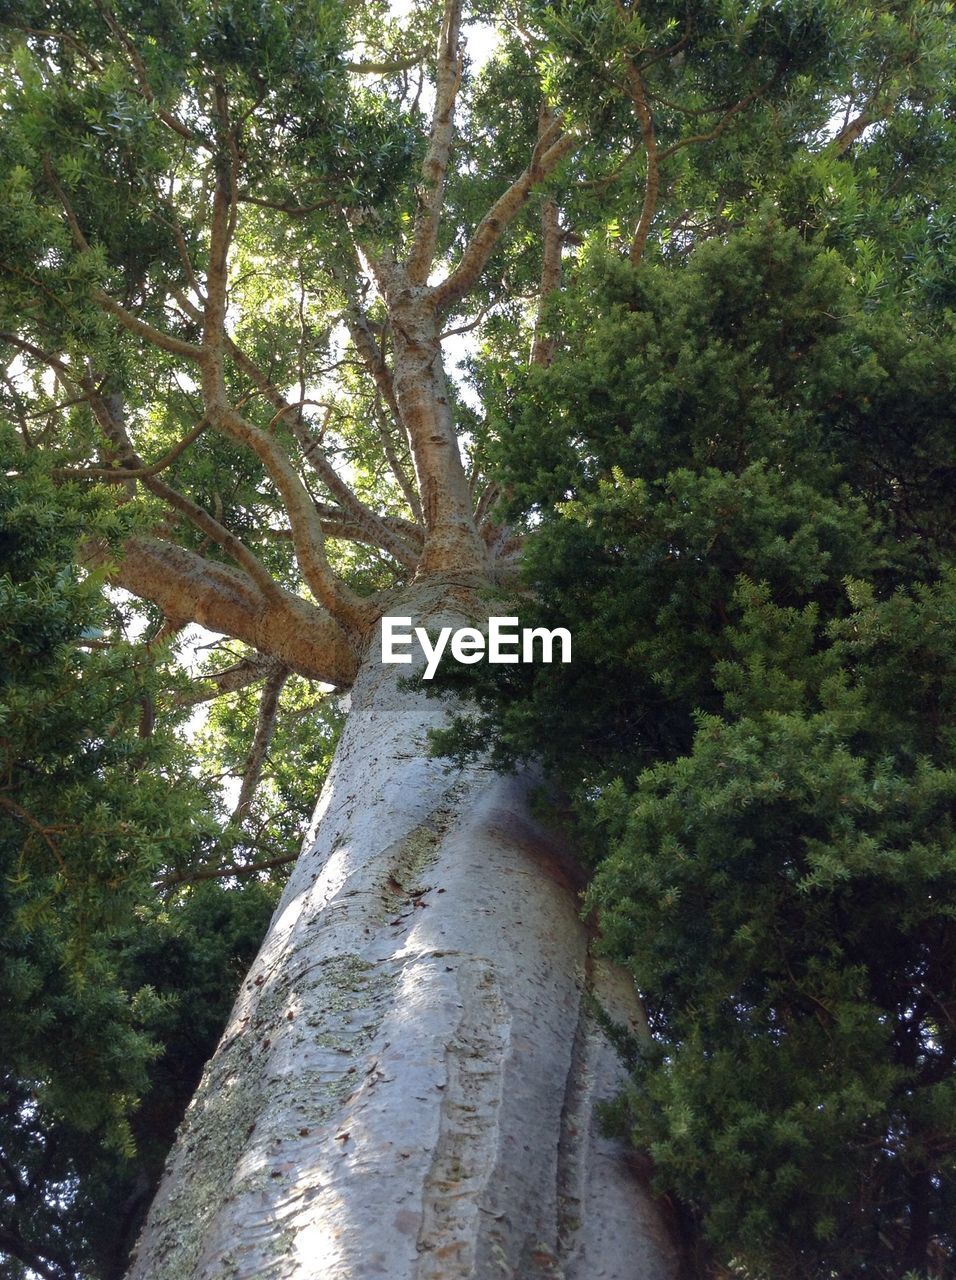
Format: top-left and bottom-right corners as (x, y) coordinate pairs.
(406, 0), (465, 284)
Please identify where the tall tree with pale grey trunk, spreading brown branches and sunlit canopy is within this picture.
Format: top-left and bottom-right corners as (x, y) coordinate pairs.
(0, 0), (946, 1277)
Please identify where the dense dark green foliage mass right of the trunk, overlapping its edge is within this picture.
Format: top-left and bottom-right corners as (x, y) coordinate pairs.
(444, 225), (956, 1280)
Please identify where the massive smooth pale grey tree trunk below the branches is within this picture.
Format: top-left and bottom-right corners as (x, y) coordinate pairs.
(129, 586), (676, 1280)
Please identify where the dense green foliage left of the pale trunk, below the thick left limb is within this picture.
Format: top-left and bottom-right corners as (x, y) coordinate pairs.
(0, 455), (325, 1280)
